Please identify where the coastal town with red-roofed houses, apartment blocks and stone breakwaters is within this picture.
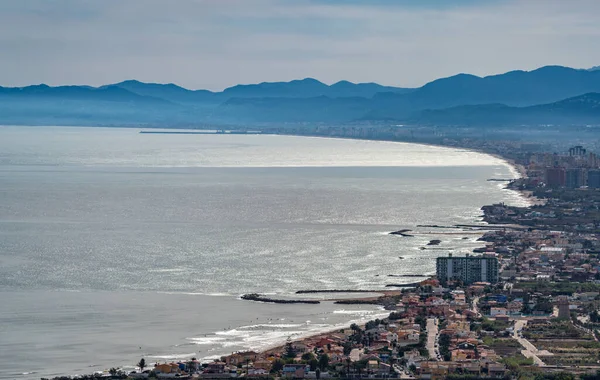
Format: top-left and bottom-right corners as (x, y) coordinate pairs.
(42, 146), (600, 380)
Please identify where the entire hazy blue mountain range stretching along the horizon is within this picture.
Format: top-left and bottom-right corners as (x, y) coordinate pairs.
(0, 66), (600, 127)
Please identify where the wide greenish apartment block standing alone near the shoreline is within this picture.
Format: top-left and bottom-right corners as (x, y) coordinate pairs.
(436, 254), (498, 285)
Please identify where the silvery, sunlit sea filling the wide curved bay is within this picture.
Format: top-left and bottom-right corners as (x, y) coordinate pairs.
(0, 126), (527, 379)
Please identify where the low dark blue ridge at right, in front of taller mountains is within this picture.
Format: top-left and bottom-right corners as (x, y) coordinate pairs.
(408, 93), (600, 126)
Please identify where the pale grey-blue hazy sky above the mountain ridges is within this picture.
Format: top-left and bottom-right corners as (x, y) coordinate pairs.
(0, 0), (600, 90)
